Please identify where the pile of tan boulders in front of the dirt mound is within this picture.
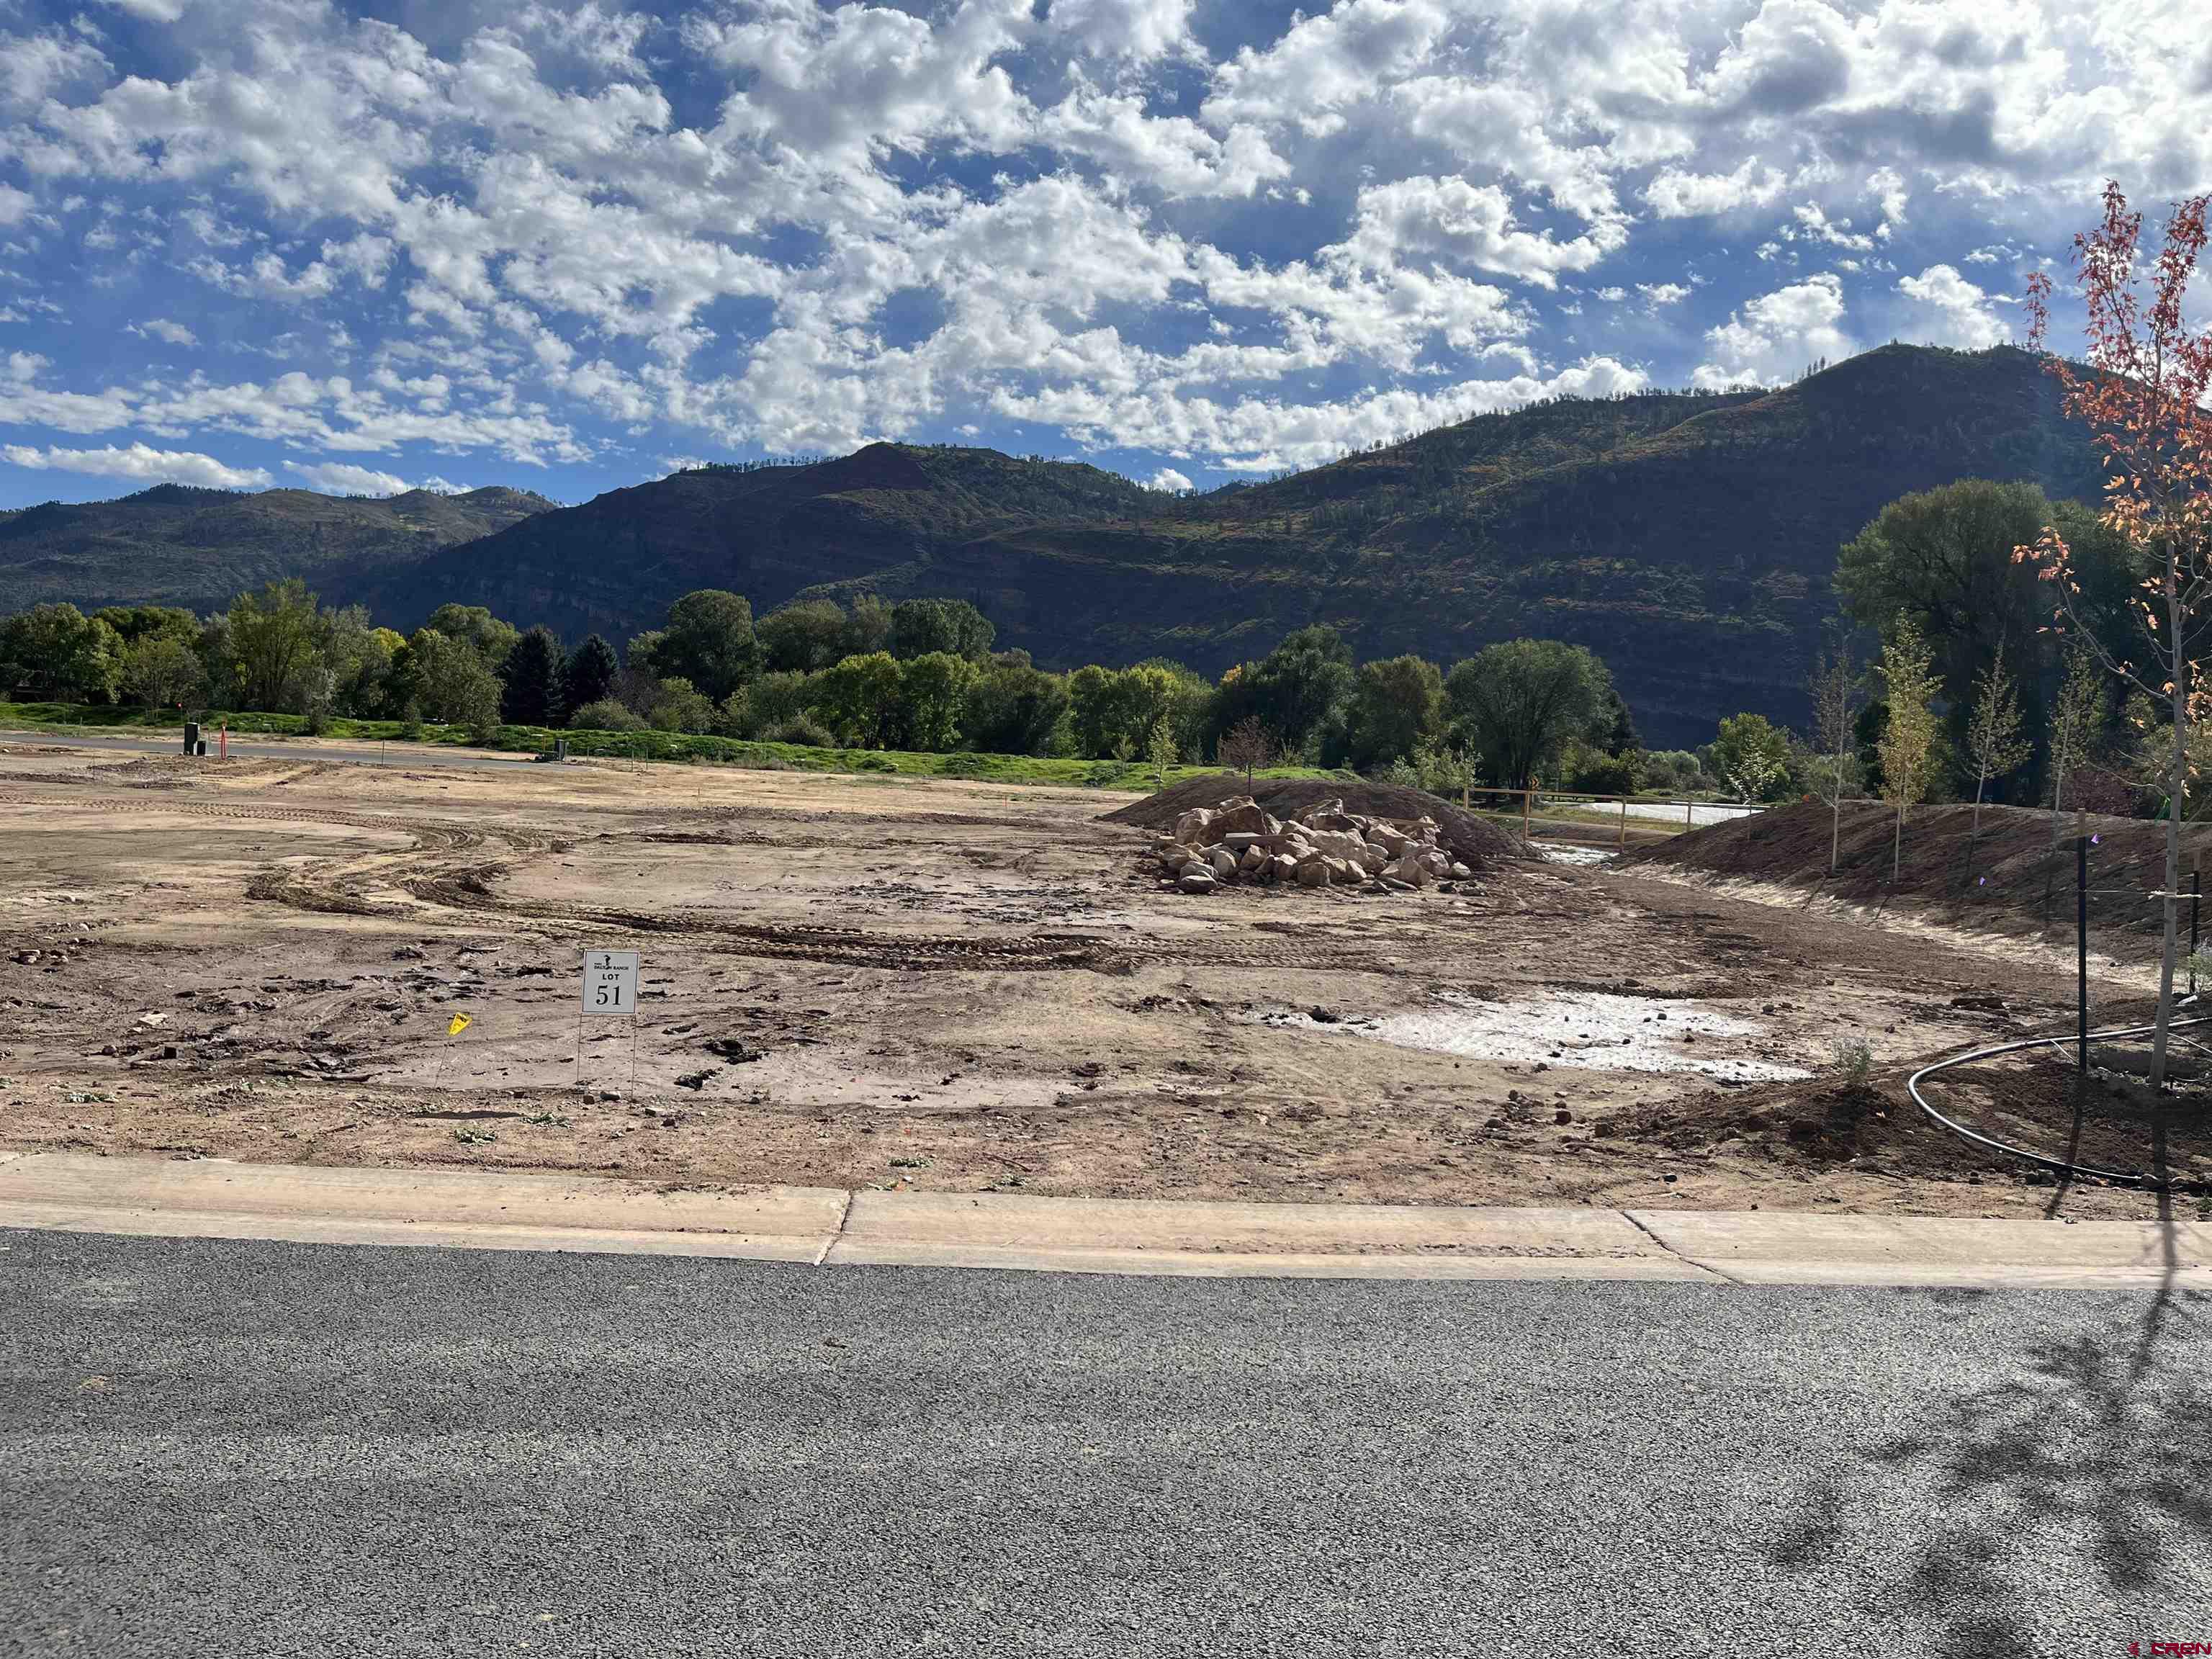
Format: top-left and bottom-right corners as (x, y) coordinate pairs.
(1153, 796), (1473, 894)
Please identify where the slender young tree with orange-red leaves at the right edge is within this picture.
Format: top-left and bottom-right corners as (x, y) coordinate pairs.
(2013, 184), (2212, 1088)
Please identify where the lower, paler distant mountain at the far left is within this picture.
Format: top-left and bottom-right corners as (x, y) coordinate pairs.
(0, 485), (555, 611)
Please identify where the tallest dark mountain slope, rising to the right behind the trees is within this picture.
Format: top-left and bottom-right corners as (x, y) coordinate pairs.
(889, 347), (2101, 745)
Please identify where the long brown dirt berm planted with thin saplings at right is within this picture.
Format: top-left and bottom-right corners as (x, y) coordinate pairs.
(1622, 801), (2212, 958)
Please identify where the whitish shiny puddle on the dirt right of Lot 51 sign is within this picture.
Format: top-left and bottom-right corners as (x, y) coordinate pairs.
(1254, 991), (1812, 1082)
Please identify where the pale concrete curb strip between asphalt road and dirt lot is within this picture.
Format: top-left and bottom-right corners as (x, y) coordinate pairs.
(0, 1153), (2212, 1290)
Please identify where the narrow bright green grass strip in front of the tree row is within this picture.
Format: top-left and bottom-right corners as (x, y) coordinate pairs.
(0, 703), (1334, 794)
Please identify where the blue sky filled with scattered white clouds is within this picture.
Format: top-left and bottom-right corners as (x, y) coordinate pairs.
(0, 0), (2212, 506)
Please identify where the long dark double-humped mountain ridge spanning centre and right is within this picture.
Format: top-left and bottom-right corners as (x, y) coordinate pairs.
(0, 345), (2099, 745)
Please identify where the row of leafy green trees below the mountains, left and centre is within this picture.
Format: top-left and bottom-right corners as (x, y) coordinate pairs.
(0, 582), (1646, 790)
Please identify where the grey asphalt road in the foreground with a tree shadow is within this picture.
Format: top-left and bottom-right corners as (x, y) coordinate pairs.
(0, 1232), (2212, 1659)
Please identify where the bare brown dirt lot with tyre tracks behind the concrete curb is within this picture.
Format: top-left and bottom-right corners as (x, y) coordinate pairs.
(0, 745), (2212, 1217)
